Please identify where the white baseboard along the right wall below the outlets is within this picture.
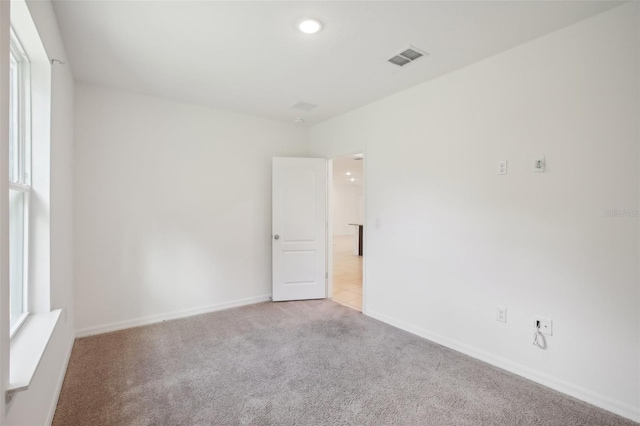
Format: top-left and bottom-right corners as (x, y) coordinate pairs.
(366, 309), (640, 422)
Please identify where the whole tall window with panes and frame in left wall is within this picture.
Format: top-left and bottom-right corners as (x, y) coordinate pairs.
(9, 30), (31, 336)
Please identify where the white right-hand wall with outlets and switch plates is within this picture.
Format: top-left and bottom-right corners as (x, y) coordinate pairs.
(310, 4), (640, 420)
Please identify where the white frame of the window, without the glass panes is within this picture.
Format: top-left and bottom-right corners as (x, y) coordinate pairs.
(9, 28), (32, 338)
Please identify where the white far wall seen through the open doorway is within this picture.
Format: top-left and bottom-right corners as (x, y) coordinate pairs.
(332, 182), (362, 235)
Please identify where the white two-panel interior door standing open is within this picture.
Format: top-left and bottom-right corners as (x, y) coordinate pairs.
(271, 157), (327, 301)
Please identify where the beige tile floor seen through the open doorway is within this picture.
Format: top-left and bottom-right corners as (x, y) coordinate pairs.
(332, 235), (362, 311)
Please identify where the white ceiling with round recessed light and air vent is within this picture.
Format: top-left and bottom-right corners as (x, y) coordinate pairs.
(54, 0), (619, 125)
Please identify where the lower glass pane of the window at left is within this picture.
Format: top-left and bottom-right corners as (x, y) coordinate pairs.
(9, 189), (26, 326)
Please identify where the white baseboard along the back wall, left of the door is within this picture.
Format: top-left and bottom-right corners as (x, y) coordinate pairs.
(76, 294), (271, 338)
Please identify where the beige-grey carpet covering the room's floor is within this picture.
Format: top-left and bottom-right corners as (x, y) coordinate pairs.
(53, 300), (634, 426)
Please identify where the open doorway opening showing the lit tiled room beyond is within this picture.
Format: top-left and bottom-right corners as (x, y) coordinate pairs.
(330, 154), (364, 311)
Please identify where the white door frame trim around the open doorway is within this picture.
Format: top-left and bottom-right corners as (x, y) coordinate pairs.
(326, 148), (369, 314)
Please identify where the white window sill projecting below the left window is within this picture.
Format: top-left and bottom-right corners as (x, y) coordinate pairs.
(6, 309), (62, 401)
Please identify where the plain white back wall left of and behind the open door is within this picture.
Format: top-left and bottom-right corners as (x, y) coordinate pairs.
(75, 84), (308, 334)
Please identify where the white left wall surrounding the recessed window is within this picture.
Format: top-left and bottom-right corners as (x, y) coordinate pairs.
(0, 0), (74, 426)
